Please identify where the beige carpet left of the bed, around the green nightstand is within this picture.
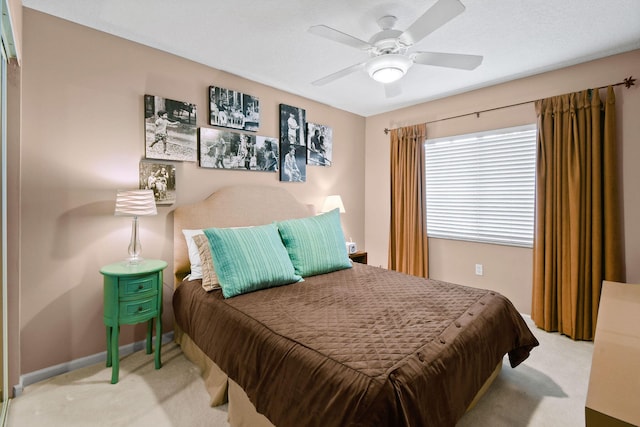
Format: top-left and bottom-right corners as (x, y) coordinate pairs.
(7, 343), (229, 427)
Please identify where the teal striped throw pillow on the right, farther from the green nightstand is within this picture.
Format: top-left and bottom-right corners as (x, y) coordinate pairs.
(277, 209), (351, 277)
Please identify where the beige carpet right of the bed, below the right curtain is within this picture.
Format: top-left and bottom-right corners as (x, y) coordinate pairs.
(457, 316), (593, 427)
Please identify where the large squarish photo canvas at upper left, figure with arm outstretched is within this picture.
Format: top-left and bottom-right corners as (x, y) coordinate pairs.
(144, 95), (198, 162)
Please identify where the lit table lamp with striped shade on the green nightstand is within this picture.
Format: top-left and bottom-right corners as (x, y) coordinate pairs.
(115, 190), (158, 264)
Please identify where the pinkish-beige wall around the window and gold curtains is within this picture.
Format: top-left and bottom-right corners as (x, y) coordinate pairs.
(365, 50), (640, 313)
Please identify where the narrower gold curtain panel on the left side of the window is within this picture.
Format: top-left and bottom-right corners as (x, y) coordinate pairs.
(389, 124), (429, 277)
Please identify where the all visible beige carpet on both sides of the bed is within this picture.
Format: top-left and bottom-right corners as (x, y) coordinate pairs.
(7, 318), (593, 427)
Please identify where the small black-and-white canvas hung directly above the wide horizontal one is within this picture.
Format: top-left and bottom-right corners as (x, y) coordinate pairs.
(209, 86), (260, 132)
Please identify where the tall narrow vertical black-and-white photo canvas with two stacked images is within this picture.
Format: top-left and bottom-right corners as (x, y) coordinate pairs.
(280, 104), (307, 182)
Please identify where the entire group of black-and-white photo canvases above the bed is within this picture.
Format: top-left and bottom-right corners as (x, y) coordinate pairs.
(140, 86), (333, 204)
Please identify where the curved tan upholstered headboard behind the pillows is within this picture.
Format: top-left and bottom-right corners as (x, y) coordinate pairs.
(173, 185), (314, 286)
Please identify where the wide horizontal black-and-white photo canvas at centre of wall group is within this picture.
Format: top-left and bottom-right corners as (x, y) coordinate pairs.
(200, 128), (277, 172)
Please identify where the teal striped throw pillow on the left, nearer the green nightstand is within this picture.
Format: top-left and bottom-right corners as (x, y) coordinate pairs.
(204, 224), (302, 298)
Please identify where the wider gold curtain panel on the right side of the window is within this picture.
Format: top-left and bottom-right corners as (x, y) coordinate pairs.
(532, 86), (624, 340)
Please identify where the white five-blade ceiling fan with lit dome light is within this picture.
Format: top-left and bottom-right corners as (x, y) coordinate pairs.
(309, 0), (482, 97)
